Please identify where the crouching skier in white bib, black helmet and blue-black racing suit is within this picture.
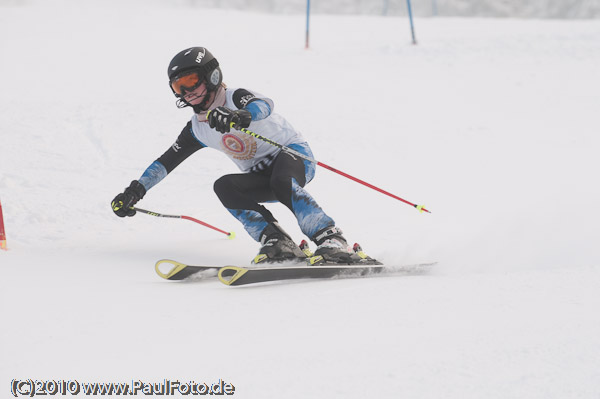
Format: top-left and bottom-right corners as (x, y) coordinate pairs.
(111, 47), (356, 263)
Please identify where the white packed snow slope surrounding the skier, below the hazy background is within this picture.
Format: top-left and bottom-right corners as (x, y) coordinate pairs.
(0, 1), (600, 399)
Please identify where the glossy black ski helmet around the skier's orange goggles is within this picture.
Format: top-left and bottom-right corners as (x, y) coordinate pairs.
(167, 47), (223, 107)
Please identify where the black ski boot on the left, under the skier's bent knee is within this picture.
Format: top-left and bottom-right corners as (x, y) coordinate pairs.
(252, 222), (306, 264)
